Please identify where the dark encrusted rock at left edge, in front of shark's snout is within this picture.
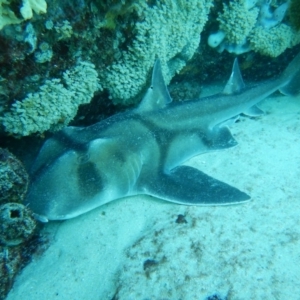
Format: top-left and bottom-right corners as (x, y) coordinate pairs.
(0, 148), (45, 299)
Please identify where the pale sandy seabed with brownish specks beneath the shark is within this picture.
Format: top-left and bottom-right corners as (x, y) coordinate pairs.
(7, 92), (300, 300)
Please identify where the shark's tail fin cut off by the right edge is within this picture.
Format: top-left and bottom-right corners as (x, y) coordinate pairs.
(279, 53), (300, 96)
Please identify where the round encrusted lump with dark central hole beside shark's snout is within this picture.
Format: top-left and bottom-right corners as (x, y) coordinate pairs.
(0, 203), (36, 246)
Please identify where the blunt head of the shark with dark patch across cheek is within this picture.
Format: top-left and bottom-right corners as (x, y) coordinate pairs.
(26, 139), (139, 221)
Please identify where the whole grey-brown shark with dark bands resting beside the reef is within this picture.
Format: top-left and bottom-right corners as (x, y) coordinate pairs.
(26, 54), (300, 221)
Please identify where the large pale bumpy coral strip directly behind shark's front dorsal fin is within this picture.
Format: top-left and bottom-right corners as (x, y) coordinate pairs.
(100, 0), (212, 105)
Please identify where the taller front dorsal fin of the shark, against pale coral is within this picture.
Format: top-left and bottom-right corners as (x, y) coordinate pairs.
(138, 59), (172, 111)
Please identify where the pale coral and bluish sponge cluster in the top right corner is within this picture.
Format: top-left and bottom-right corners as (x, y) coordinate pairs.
(208, 0), (300, 57)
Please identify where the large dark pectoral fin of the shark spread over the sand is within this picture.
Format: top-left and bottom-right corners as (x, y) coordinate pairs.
(146, 166), (250, 205)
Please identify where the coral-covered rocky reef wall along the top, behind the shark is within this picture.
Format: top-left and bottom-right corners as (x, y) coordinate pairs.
(0, 0), (300, 137)
